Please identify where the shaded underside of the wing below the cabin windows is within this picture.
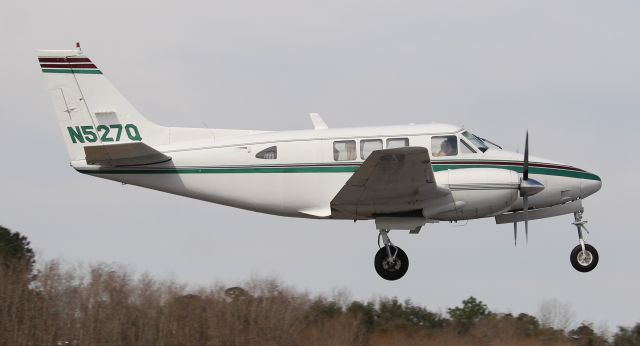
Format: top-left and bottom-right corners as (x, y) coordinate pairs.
(331, 147), (450, 219)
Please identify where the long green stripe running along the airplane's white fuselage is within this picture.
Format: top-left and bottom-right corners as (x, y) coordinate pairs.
(79, 163), (600, 181)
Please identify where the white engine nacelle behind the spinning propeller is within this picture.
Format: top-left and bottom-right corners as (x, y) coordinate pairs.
(433, 168), (520, 220)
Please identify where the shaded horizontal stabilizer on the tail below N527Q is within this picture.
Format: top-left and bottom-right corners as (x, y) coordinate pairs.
(84, 142), (171, 167)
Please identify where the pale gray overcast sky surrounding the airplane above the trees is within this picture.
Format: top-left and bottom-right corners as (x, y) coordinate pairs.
(0, 0), (640, 327)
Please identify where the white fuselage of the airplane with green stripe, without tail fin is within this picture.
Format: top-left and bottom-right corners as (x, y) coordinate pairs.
(73, 125), (601, 220)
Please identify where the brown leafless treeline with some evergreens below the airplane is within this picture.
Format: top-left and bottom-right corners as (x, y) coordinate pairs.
(0, 228), (640, 346)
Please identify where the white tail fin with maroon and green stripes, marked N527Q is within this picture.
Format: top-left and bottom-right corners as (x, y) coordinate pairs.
(38, 45), (170, 161)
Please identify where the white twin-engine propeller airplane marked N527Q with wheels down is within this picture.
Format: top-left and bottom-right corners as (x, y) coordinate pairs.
(38, 44), (602, 280)
